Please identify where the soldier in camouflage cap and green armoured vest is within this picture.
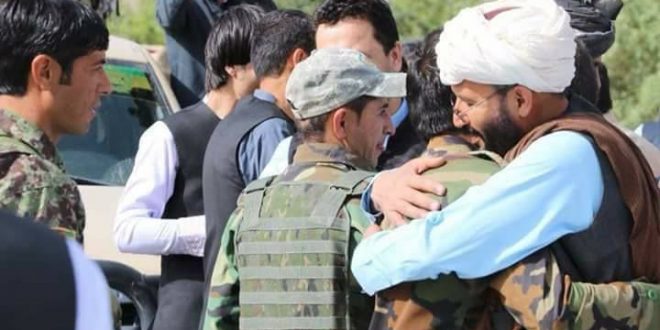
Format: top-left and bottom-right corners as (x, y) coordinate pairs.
(204, 48), (405, 329)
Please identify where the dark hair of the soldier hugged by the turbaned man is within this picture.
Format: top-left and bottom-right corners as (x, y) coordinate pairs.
(406, 29), (457, 141)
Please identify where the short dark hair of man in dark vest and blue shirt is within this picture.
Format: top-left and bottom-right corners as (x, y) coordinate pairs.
(250, 10), (315, 79)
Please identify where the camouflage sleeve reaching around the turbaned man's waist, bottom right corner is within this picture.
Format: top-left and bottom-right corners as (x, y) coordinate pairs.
(491, 249), (660, 329)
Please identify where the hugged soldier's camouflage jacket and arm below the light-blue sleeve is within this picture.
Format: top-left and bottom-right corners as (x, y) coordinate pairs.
(370, 250), (660, 330)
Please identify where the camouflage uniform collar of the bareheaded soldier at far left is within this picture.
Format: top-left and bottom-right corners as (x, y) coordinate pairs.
(0, 109), (64, 167)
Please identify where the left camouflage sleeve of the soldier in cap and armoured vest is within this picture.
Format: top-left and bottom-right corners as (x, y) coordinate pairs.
(203, 207), (243, 330)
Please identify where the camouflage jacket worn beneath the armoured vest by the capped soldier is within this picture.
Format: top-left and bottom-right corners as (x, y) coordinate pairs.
(203, 143), (373, 329)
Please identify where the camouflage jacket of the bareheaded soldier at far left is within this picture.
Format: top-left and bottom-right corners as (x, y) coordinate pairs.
(0, 109), (85, 242)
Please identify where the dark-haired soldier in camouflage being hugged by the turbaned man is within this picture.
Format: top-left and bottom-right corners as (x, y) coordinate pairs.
(370, 30), (660, 330)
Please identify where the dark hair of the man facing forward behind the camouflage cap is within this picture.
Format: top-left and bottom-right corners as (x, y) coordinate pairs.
(314, 0), (399, 54)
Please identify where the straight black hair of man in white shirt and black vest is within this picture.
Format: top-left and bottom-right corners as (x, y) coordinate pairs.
(204, 5), (264, 91)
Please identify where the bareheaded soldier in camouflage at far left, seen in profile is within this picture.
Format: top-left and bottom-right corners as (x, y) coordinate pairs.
(0, 0), (111, 242)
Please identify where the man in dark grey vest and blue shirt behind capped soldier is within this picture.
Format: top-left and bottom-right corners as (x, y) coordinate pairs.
(202, 11), (314, 283)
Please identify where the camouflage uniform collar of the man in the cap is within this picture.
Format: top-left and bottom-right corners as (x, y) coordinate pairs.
(293, 143), (374, 171)
